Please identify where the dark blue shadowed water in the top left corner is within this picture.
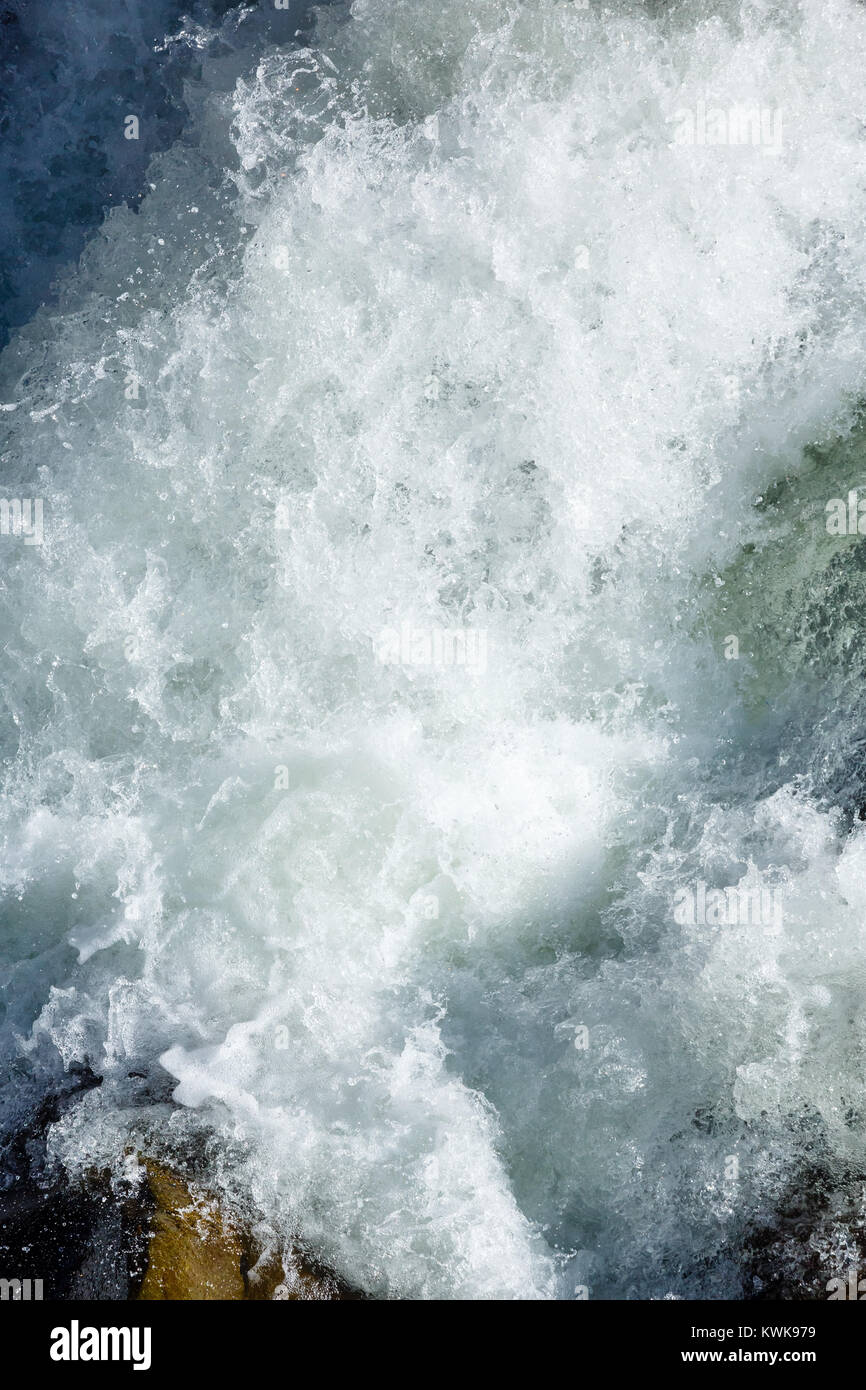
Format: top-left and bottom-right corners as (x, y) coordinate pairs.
(0, 0), (318, 346)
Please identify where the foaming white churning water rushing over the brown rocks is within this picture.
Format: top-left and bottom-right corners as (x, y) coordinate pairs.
(0, 0), (866, 1300)
